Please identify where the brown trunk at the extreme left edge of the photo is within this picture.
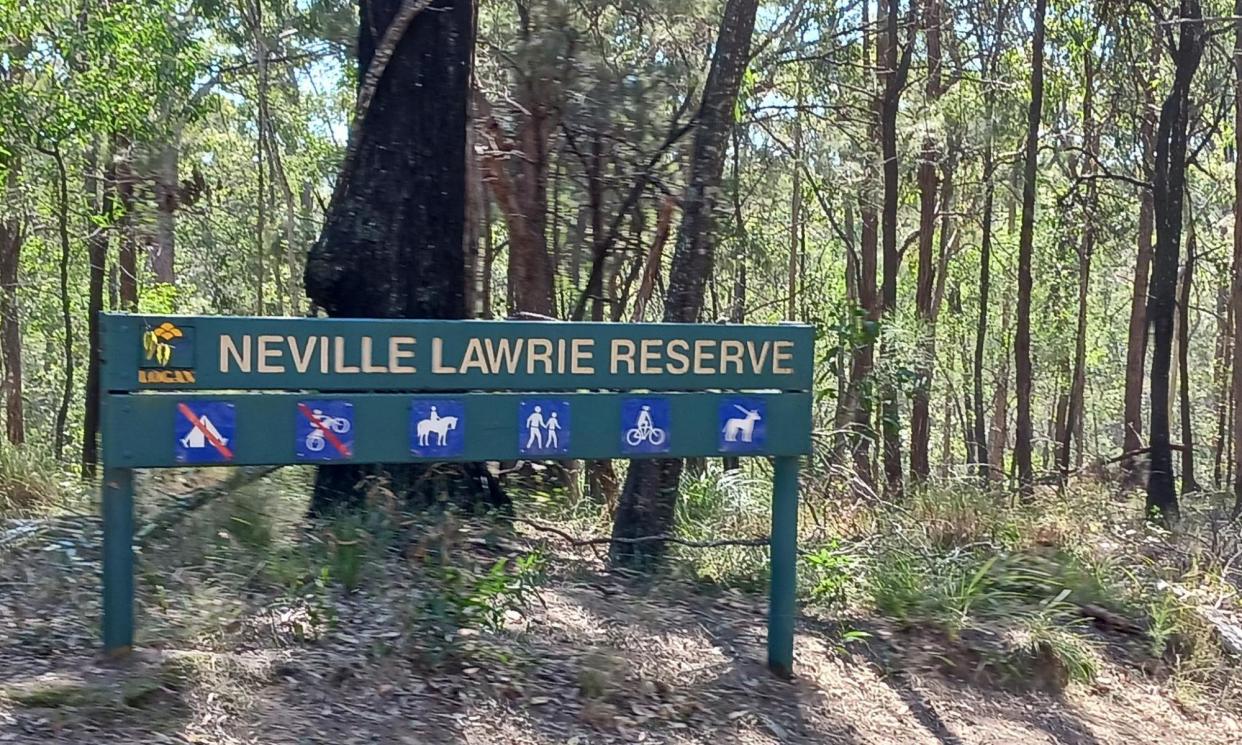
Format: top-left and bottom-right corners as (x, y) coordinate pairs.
(0, 163), (26, 445)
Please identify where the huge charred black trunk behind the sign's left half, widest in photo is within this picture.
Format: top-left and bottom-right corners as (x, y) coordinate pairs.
(306, 0), (504, 513)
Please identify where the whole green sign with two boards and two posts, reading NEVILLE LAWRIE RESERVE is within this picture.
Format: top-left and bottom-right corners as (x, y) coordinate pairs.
(101, 314), (814, 675)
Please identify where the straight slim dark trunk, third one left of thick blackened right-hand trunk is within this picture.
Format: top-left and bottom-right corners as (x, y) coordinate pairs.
(1013, 0), (1048, 494)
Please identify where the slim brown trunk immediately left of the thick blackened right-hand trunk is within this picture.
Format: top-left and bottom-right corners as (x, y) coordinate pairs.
(1122, 22), (1157, 487)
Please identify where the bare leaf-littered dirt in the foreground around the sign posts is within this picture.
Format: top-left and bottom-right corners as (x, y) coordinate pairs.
(0, 506), (1242, 745)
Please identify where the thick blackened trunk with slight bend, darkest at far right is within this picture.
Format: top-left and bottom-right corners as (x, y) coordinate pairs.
(1146, 0), (1203, 522)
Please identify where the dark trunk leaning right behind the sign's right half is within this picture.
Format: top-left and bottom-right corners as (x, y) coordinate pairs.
(610, 0), (759, 566)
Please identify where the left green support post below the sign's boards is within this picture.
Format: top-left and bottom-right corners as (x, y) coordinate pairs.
(103, 468), (134, 654)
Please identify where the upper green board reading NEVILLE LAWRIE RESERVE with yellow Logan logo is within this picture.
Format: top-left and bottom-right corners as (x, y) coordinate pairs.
(103, 315), (812, 390)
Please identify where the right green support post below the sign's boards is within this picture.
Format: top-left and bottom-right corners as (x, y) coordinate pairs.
(768, 456), (799, 678)
